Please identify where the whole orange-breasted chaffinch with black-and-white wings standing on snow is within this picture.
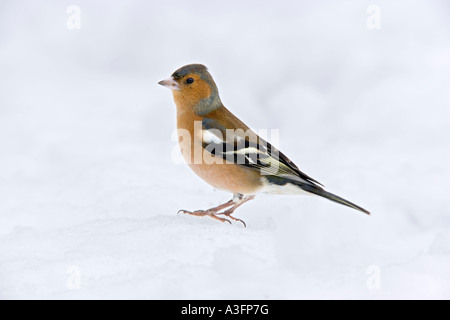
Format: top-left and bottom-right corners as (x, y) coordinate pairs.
(158, 64), (370, 227)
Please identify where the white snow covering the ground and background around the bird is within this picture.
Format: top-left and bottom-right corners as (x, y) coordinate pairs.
(0, 0), (450, 299)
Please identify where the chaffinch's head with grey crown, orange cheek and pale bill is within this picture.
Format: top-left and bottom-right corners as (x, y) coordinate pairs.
(158, 64), (222, 115)
